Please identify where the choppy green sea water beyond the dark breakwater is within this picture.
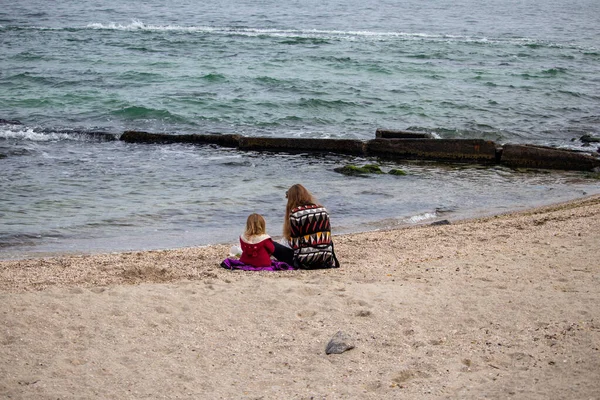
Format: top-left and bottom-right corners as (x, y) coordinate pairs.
(0, 0), (600, 144)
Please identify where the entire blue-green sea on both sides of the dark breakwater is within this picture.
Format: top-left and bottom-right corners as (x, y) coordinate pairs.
(0, 0), (600, 259)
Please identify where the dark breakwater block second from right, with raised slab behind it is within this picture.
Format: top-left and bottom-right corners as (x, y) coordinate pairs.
(367, 139), (496, 163)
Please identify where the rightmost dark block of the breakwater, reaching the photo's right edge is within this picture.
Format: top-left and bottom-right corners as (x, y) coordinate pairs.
(501, 144), (600, 171)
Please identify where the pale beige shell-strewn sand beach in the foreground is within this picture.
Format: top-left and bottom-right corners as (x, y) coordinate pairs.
(0, 196), (600, 399)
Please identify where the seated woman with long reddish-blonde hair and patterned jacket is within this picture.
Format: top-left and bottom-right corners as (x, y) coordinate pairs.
(273, 184), (340, 269)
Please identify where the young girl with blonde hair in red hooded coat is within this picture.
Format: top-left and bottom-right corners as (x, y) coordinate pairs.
(240, 213), (275, 267)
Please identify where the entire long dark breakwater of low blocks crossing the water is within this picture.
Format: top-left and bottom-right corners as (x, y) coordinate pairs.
(118, 131), (600, 175)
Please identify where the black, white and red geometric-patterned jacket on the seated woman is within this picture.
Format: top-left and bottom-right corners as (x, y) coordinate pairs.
(290, 204), (339, 269)
